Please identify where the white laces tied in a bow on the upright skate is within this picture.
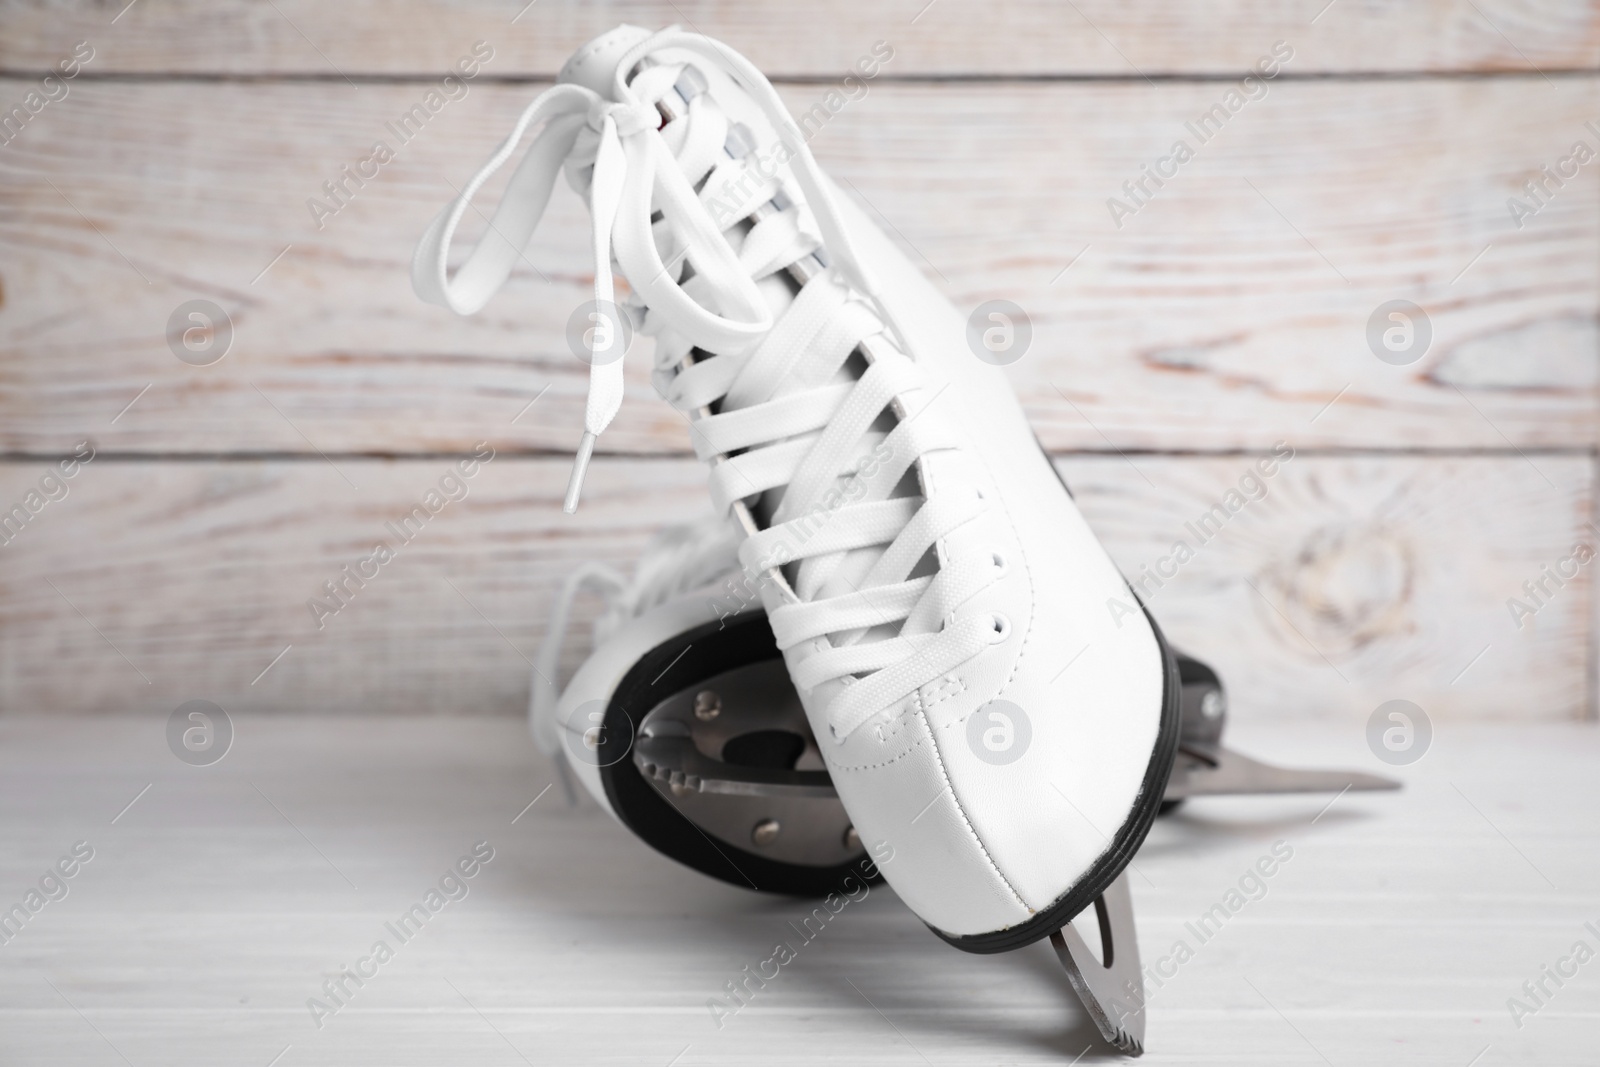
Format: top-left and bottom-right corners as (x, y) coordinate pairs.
(413, 29), (1005, 742)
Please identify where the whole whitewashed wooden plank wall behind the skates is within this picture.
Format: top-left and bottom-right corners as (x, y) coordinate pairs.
(0, 0), (1600, 718)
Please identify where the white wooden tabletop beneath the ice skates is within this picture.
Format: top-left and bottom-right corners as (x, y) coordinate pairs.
(0, 715), (1600, 1067)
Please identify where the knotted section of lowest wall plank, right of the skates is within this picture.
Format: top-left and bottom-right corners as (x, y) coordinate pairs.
(1059, 454), (1600, 718)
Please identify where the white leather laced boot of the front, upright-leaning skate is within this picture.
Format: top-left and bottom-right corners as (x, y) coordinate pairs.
(413, 27), (1179, 952)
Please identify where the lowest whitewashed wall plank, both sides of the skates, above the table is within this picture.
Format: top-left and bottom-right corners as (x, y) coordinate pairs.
(0, 454), (1594, 720)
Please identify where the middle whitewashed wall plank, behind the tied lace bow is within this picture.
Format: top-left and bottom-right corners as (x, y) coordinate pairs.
(0, 78), (1600, 456)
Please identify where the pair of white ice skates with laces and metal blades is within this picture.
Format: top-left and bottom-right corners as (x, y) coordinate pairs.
(413, 27), (1395, 1051)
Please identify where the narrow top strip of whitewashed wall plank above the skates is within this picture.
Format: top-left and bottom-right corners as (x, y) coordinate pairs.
(0, 0), (1600, 77)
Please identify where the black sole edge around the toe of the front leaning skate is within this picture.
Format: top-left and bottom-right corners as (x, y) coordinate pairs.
(928, 605), (1182, 955)
